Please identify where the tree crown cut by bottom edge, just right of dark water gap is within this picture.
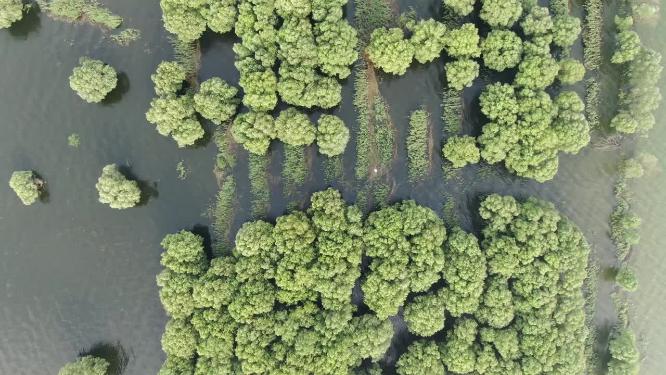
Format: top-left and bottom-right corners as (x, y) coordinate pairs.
(396, 341), (444, 375)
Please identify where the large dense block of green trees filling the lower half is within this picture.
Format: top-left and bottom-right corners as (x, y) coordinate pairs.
(157, 189), (589, 375)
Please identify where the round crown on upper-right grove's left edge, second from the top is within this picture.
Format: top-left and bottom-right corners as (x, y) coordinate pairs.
(481, 30), (523, 72)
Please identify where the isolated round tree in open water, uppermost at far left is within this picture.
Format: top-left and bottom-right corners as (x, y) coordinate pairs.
(69, 57), (118, 103)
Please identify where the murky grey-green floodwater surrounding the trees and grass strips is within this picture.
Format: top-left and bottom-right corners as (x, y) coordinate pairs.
(0, 0), (666, 375)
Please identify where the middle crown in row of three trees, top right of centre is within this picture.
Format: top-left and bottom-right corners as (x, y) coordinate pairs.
(409, 19), (446, 64)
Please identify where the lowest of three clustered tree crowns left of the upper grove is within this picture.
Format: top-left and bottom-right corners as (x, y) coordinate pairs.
(146, 95), (204, 147)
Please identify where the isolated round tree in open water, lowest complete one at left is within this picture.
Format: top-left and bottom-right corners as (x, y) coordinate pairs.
(95, 164), (141, 210)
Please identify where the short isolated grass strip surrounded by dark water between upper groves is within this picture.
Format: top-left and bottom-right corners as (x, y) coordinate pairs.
(407, 109), (430, 183)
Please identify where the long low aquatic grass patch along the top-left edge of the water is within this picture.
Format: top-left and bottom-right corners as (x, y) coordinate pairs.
(38, 0), (123, 29)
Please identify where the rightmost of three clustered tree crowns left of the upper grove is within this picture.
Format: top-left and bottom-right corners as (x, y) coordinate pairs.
(194, 77), (240, 125)
